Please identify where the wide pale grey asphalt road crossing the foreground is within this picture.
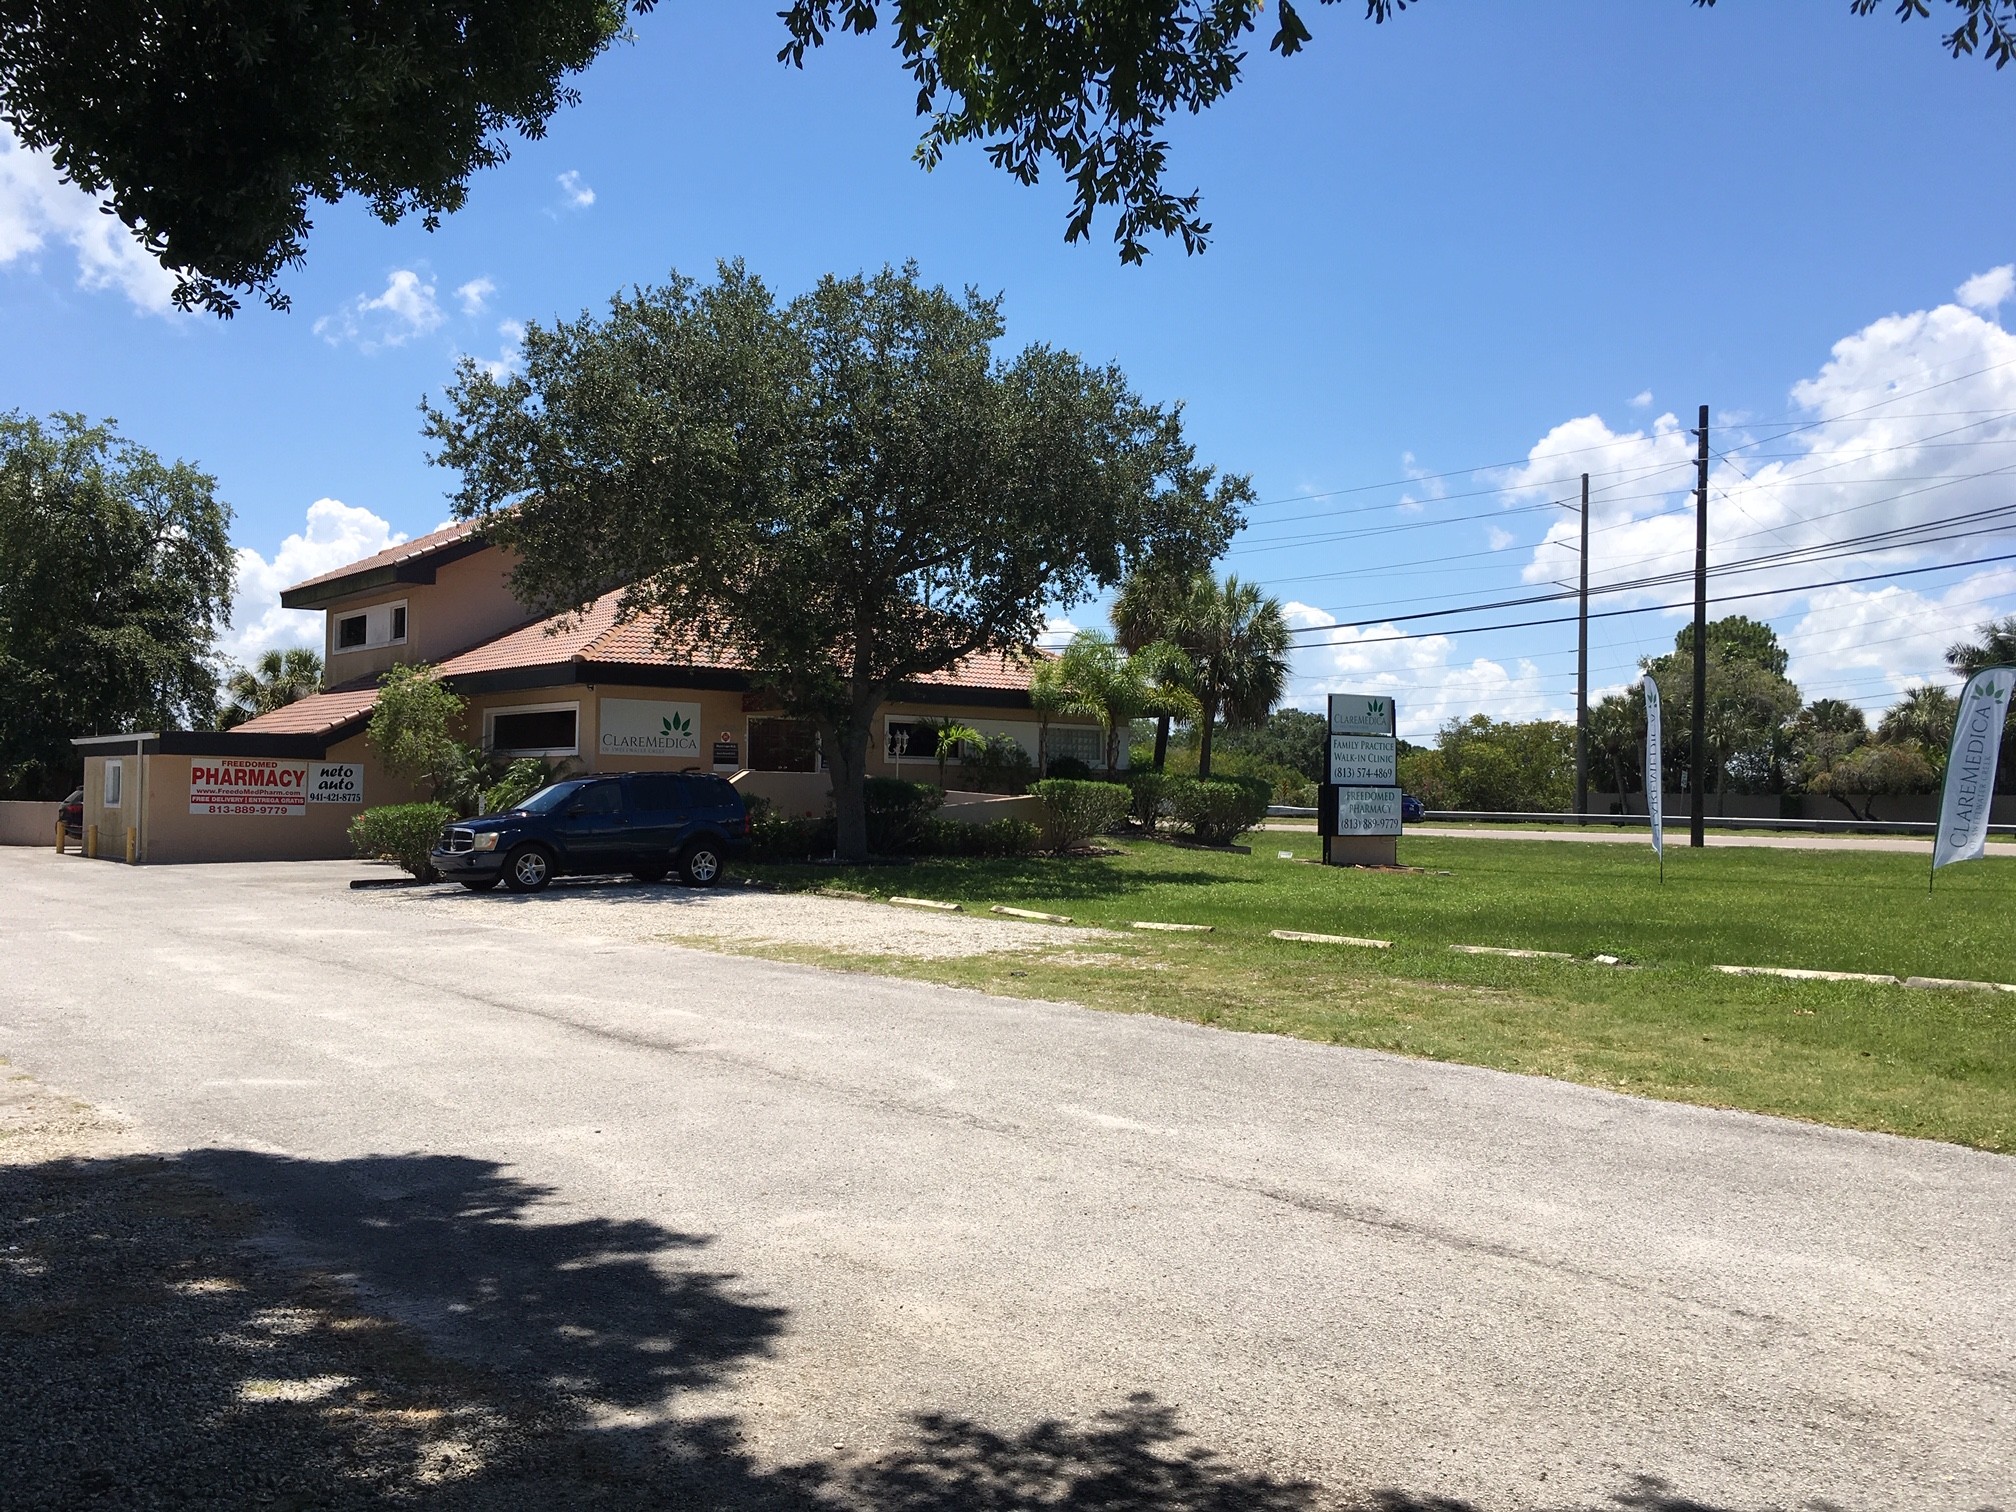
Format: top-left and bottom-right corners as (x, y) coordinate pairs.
(0, 851), (2016, 1512)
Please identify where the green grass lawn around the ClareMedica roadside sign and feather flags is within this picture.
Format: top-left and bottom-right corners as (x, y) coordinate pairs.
(737, 833), (2016, 1151)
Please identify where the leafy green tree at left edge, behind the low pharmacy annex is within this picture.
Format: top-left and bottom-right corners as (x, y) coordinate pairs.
(0, 411), (232, 798)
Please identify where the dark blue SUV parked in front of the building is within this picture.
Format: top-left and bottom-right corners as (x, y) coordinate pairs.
(431, 772), (750, 893)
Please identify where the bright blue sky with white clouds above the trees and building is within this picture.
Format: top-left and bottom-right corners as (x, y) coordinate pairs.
(0, 0), (2016, 732)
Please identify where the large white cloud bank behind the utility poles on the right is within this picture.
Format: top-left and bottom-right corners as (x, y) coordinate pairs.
(1290, 274), (2016, 734)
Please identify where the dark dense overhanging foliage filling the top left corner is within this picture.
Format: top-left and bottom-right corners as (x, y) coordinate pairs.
(0, 0), (623, 314)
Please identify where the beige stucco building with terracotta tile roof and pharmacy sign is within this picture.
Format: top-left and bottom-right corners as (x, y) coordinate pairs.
(77, 524), (1103, 863)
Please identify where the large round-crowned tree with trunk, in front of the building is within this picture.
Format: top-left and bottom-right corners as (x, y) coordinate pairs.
(427, 264), (1252, 855)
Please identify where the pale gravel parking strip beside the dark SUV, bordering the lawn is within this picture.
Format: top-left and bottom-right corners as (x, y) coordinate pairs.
(365, 881), (1115, 960)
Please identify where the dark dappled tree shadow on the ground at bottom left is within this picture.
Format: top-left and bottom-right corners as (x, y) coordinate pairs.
(0, 1149), (1854, 1512)
